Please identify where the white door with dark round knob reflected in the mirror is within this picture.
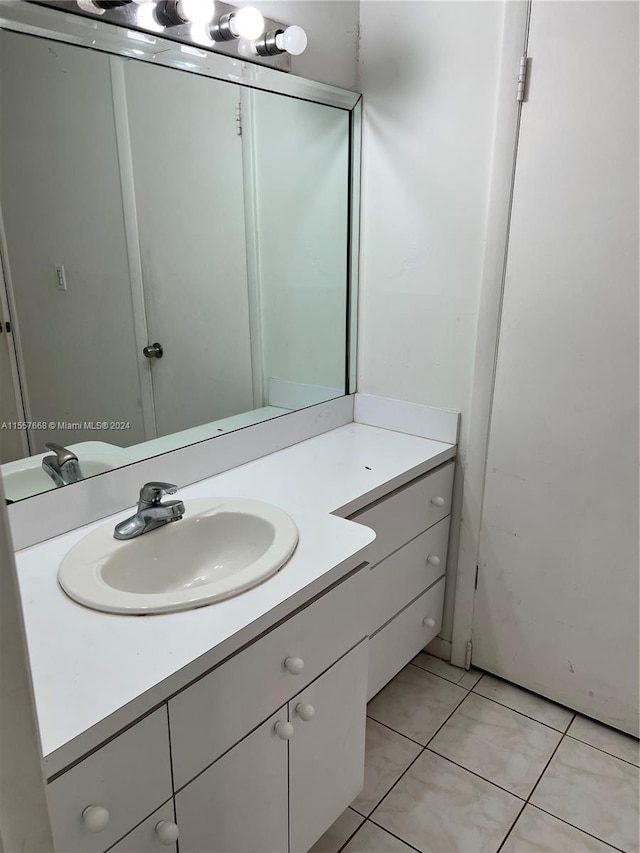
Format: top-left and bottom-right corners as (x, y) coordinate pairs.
(124, 62), (254, 435)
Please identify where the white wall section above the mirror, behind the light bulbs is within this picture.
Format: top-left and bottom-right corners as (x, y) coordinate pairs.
(236, 0), (360, 90)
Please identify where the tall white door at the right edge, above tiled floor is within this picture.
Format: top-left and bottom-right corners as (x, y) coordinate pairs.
(473, 0), (638, 734)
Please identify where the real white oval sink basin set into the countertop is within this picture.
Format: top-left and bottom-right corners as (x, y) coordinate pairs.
(58, 498), (298, 615)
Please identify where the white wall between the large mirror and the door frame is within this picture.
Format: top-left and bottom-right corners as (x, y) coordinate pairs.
(358, 0), (504, 639)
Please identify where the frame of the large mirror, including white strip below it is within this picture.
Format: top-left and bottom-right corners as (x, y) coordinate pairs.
(0, 0), (362, 549)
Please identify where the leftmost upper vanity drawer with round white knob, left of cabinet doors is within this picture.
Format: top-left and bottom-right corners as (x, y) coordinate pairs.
(47, 707), (172, 853)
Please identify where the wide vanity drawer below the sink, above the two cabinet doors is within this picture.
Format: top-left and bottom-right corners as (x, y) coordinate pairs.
(169, 568), (369, 790)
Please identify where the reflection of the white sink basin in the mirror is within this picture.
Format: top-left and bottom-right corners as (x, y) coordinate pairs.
(2, 441), (135, 501)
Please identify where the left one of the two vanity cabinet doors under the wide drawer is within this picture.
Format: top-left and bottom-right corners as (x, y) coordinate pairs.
(176, 708), (287, 853)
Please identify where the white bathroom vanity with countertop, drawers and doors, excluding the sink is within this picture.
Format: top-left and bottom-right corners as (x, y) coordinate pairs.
(17, 423), (455, 853)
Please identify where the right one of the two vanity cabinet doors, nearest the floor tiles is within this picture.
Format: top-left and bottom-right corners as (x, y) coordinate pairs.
(289, 640), (368, 853)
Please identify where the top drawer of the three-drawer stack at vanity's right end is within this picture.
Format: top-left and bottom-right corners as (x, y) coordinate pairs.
(349, 462), (455, 564)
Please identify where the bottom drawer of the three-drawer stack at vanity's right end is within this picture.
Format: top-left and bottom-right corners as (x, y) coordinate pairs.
(367, 578), (445, 701)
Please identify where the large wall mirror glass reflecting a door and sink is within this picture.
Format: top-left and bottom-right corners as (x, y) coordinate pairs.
(0, 6), (355, 501)
